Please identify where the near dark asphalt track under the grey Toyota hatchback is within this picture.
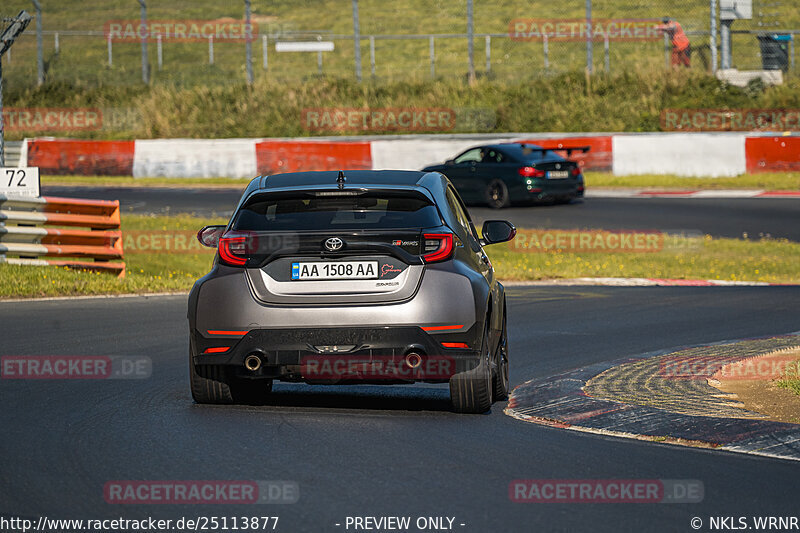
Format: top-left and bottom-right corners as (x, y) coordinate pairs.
(0, 286), (800, 532)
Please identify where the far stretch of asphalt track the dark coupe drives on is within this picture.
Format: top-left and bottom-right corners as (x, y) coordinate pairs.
(42, 186), (800, 241)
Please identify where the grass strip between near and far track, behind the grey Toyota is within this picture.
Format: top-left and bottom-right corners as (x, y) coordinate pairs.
(0, 215), (800, 298)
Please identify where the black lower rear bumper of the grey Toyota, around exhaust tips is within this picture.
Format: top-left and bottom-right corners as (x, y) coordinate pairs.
(191, 326), (480, 383)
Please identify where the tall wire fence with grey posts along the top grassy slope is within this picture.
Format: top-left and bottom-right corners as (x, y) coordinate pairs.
(3, 0), (800, 87)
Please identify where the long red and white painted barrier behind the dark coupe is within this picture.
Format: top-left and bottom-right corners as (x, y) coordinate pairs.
(26, 133), (800, 178)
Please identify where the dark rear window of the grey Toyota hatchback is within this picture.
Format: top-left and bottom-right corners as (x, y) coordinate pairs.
(233, 191), (442, 231)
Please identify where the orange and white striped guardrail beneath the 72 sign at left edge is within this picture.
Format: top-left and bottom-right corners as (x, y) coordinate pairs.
(0, 194), (125, 278)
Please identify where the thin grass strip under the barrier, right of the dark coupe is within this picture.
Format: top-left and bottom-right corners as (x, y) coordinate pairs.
(585, 172), (800, 191)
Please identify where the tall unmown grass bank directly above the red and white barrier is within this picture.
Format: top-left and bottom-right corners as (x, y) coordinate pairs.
(5, 72), (800, 140)
